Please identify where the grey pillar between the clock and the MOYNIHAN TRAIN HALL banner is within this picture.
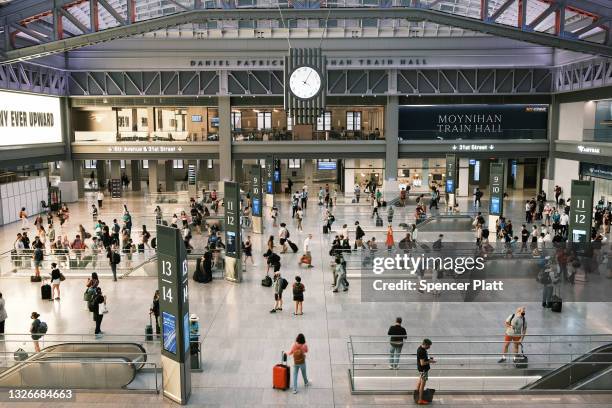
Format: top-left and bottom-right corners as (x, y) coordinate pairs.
(383, 96), (399, 200)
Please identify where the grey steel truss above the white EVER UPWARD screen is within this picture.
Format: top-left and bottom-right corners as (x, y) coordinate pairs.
(0, 63), (68, 96)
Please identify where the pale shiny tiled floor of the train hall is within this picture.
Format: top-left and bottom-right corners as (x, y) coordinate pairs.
(0, 190), (612, 407)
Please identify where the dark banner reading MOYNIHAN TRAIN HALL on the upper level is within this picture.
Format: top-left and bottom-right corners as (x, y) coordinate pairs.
(398, 105), (548, 140)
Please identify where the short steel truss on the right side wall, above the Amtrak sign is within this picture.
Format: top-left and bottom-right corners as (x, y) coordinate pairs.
(554, 58), (612, 92)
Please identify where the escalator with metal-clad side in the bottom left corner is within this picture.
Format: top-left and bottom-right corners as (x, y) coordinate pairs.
(0, 342), (147, 389)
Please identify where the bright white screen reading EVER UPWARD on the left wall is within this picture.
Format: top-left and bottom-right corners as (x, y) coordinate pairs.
(0, 91), (62, 146)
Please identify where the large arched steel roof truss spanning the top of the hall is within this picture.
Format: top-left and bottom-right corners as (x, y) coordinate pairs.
(0, 0), (612, 63)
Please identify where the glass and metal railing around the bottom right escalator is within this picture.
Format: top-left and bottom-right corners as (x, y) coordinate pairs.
(347, 334), (612, 394)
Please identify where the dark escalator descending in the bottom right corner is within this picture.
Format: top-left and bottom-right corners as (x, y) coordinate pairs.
(522, 343), (612, 391)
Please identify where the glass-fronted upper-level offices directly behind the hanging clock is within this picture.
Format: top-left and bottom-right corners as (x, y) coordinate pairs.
(231, 106), (384, 141)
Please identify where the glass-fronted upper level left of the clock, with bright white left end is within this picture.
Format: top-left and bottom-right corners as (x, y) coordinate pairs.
(72, 106), (219, 143)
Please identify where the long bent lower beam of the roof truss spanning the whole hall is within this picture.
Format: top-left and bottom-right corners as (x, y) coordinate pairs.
(1, 7), (612, 63)
